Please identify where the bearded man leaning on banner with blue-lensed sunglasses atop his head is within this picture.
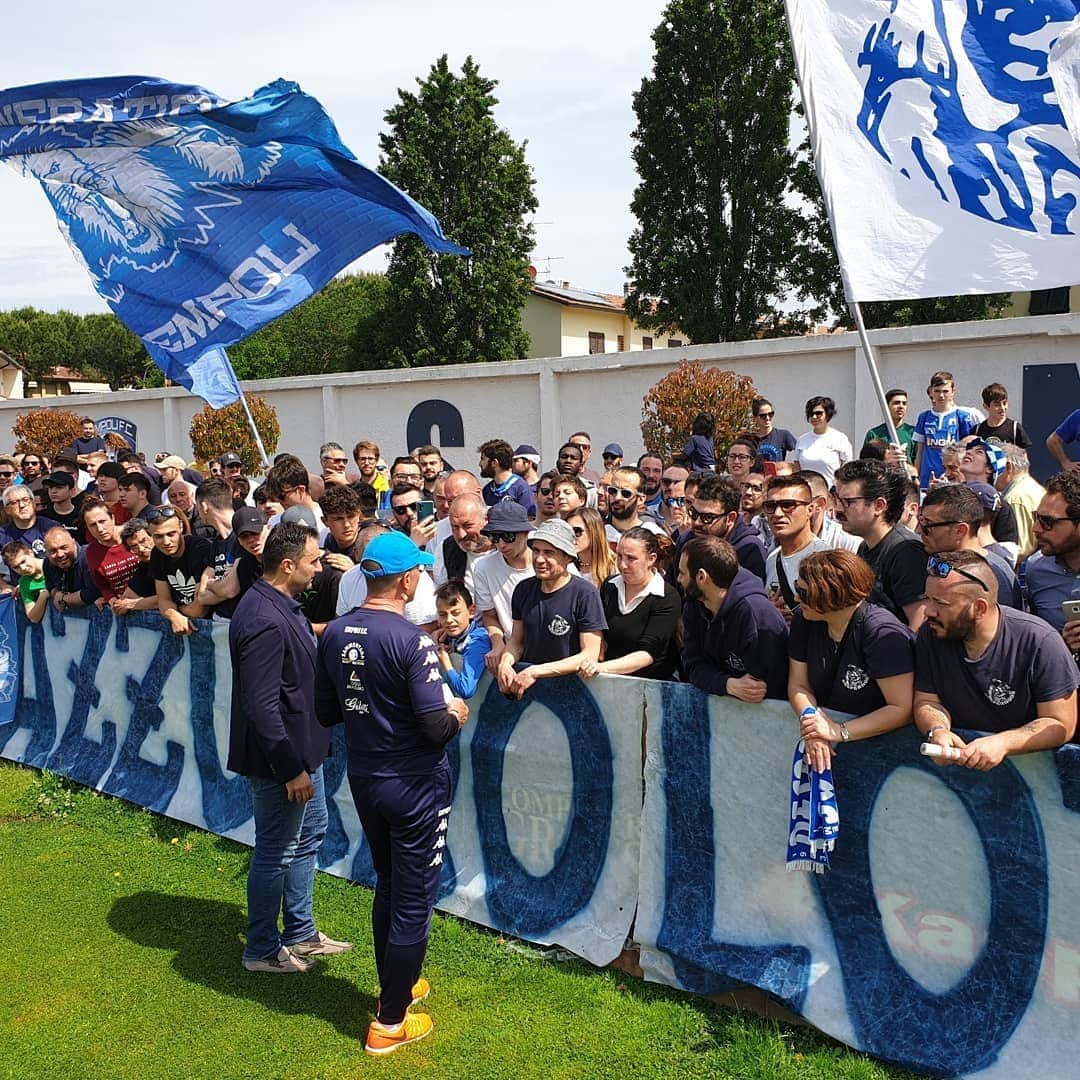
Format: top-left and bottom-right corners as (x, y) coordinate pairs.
(915, 551), (1080, 771)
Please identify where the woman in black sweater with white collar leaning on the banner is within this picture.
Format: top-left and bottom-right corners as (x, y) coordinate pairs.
(579, 526), (681, 678)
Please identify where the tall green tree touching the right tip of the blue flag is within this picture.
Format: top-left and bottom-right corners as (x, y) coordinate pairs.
(379, 55), (537, 367)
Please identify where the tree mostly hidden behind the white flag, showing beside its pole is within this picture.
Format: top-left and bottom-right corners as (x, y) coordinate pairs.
(789, 114), (1010, 333)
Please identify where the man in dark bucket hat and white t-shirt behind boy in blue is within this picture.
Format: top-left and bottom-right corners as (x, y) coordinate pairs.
(472, 502), (532, 675)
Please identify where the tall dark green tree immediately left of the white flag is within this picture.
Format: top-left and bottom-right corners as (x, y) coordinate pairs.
(626, 0), (798, 341)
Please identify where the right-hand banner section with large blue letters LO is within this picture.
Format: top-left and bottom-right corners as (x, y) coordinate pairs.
(635, 684), (1080, 1078)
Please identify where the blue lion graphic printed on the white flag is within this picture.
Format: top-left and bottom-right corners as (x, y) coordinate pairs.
(858, 0), (1080, 234)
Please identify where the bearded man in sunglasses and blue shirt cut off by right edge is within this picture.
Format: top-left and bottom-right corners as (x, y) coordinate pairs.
(1024, 471), (1080, 656)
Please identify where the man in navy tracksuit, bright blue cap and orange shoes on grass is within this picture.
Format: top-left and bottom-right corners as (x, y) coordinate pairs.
(315, 532), (469, 1054)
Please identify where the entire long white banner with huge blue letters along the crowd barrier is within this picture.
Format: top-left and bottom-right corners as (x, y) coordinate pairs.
(0, 600), (1080, 1078)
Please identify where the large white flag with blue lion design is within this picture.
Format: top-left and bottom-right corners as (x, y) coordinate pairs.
(786, 0), (1080, 300)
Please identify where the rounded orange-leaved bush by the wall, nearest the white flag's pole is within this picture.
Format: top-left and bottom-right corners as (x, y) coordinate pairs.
(642, 360), (757, 461)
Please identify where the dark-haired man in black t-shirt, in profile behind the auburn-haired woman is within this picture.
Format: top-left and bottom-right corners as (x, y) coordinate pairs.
(836, 460), (927, 630)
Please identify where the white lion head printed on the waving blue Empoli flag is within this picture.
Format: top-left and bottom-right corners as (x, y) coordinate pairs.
(9, 120), (281, 302)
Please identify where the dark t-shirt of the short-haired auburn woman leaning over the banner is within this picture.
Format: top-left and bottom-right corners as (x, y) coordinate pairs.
(787, 604), (915, 716)
